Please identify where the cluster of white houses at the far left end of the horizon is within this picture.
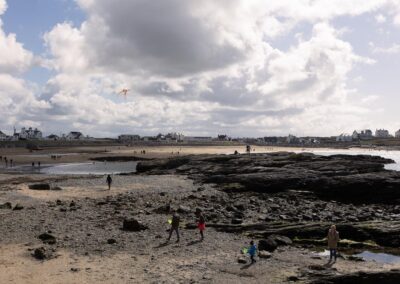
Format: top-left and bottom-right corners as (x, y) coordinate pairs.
(0, 127), (90, 141)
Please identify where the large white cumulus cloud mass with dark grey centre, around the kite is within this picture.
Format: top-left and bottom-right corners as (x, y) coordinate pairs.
(35, 0), (389, 135)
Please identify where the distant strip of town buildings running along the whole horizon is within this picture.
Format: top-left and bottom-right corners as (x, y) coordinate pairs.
(0, 127), (400, 148)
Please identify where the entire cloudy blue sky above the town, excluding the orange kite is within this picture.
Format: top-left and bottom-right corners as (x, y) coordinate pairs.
(0, 0), (400, 137)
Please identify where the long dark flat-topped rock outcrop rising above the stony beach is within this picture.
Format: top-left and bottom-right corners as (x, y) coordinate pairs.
(137, 152), (400, 203)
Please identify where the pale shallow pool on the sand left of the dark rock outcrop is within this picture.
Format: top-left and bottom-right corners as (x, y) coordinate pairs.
(40, 162), (137, 175)
